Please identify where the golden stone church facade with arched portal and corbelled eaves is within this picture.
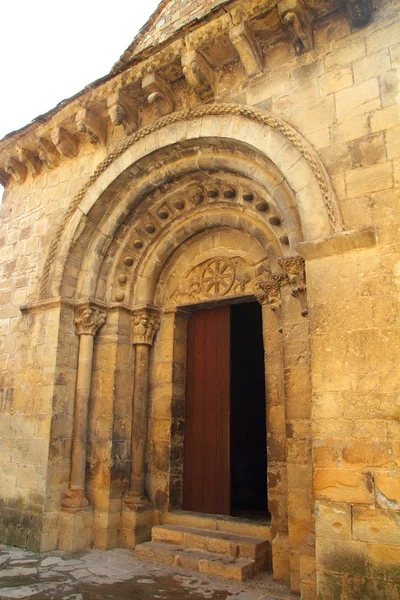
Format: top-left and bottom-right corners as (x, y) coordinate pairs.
(0, 0), (400, 600)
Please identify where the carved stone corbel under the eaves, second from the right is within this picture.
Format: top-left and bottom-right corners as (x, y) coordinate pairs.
(278, 0), (313, 54)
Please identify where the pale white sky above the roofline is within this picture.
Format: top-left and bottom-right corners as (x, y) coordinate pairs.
(0, 0), (159, 139)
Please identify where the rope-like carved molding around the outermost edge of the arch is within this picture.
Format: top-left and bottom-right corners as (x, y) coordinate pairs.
(40, 104), (339, 300)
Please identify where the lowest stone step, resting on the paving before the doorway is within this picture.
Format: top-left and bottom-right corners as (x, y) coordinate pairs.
(135, 541), (257, 581)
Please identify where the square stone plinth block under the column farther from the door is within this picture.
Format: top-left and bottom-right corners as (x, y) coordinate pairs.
(58, 506), (93, 552)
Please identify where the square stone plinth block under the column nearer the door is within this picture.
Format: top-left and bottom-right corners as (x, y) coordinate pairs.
(120, 503), (154, 548)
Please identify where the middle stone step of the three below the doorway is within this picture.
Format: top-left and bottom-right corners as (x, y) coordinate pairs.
(151, 524), (271, 570)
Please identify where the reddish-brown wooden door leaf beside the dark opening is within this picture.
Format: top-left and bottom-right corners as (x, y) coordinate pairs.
(183, 306), (230, 515)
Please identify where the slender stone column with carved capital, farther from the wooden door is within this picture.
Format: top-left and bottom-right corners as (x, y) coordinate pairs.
(61, 305), (106, 511)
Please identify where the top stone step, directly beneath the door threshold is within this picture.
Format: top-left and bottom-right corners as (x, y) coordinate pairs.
(161, 510), (271, 541)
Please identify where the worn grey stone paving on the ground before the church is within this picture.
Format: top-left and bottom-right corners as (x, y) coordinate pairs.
(0, 546), (298, 600)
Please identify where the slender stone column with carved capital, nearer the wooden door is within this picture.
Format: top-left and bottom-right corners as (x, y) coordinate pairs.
(125, 308), (160, 509)
